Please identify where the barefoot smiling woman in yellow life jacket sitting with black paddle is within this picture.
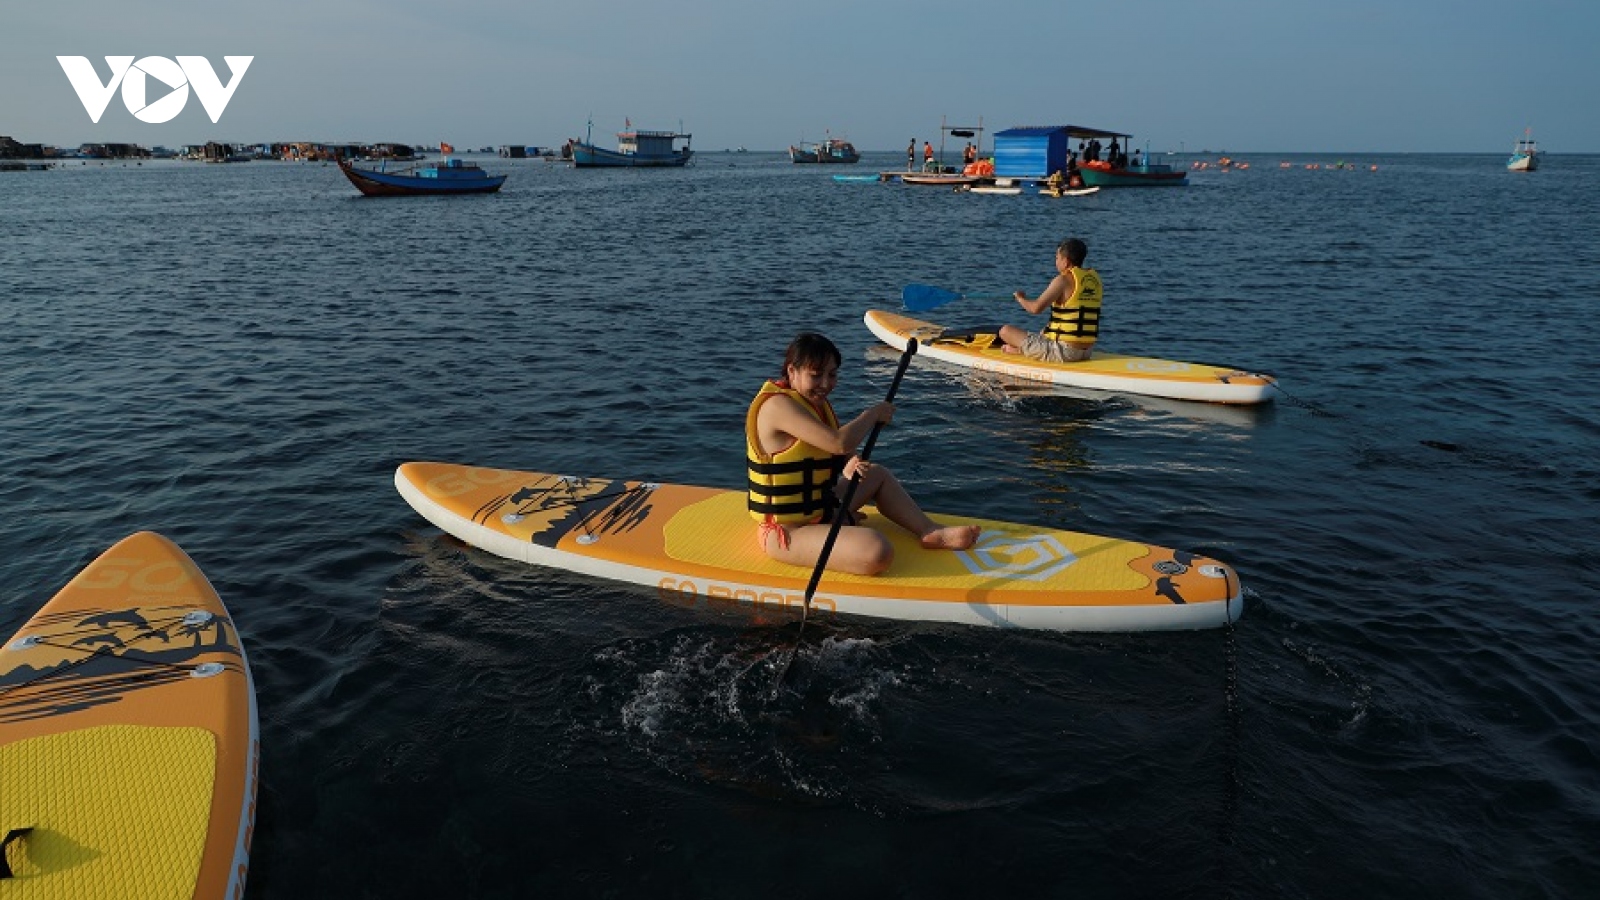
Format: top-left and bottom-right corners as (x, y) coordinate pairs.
(744, 331), (978, 575)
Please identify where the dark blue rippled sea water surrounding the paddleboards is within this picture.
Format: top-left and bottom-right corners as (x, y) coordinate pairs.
(0, 154), (1600, 900)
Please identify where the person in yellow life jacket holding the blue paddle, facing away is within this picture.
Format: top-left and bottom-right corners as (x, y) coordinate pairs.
(1000, 237), (1102, 362)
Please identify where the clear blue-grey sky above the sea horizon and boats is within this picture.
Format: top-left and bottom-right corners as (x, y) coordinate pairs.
(0, 0), (1600, 154)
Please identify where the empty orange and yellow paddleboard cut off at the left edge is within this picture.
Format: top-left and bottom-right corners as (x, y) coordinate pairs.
(0, 532), (261, 900)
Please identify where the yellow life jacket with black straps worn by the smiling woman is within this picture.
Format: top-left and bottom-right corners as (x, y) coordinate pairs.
(744, 381), (845, 525)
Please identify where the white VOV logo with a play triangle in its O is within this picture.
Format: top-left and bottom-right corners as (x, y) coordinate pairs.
(56, 56), (254, 125)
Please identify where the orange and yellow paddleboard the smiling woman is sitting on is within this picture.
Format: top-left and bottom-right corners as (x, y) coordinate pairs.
(395, 463), (1243, 631)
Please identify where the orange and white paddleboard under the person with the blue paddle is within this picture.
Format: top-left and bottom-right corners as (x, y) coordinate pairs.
(866, 309), (1274, 404)
